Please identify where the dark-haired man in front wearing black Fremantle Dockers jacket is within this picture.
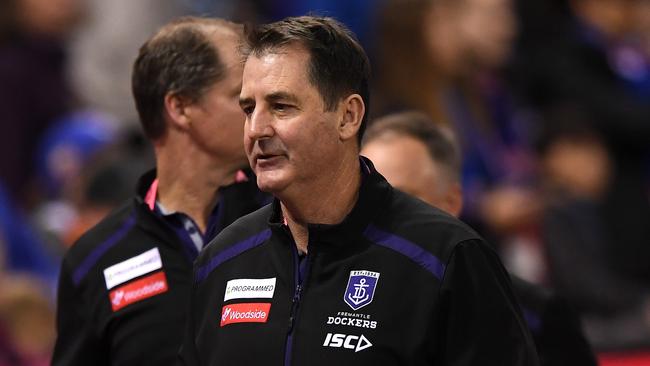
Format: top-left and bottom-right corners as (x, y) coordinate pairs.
(181, 17), (538, 366)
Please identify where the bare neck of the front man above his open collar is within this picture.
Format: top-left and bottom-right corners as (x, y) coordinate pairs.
(280, 151), (361, 253)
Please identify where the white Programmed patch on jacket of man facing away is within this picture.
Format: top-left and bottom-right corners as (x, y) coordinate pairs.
(104, 248), (162, 290)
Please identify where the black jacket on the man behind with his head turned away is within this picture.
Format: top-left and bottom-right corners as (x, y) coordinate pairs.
(52, 172), (262, 366)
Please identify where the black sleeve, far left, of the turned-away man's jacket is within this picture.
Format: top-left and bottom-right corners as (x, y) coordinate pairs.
(52, 261), (107, 366)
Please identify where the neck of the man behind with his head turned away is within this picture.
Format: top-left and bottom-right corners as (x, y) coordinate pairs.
(156, 140), (242, 232)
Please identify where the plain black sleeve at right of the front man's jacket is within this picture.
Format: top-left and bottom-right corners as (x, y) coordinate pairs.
(435, 240), (539, 366)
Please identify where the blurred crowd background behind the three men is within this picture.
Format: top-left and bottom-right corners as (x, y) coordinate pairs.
(0, 0), (650, 366)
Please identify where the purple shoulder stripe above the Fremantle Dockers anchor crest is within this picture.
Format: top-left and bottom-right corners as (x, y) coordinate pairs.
(363, 225), (445, 280)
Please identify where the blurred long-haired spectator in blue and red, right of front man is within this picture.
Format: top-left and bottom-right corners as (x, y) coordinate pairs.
(377, 0), (544, 281)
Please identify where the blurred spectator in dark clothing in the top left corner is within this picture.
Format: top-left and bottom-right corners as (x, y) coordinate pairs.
(0, 0), (83, 208)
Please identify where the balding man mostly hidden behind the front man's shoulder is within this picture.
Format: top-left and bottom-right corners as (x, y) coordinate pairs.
(361, 112), (596, 366)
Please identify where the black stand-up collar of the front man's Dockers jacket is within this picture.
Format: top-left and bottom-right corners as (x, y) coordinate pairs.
(268, 156), (393, 250)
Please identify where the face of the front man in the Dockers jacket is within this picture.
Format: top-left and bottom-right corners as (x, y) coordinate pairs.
(240, 45), (342, 195)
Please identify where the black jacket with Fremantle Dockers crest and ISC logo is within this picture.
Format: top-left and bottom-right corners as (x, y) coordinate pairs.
(181, 164), (538, 366)
